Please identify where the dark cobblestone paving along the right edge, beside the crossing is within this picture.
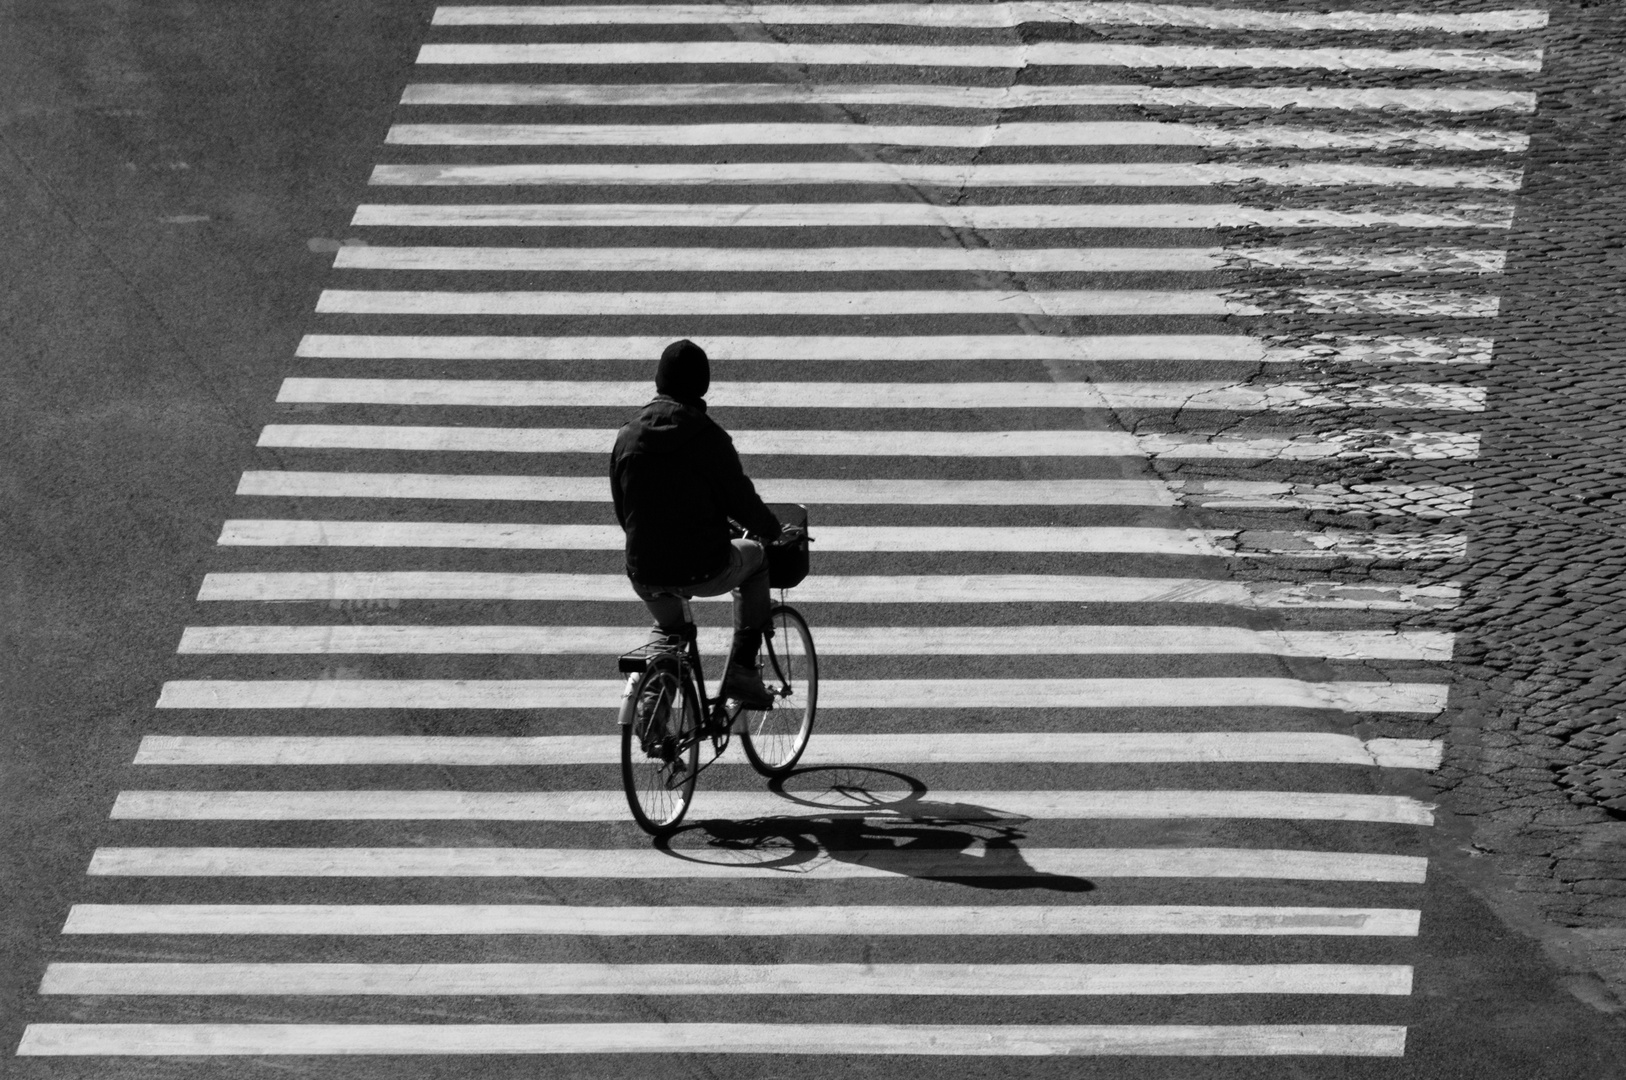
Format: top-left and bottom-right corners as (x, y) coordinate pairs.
(1437, 3), (1626, 1008)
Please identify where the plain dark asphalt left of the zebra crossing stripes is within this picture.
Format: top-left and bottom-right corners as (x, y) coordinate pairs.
(0, 2), (431, 1053)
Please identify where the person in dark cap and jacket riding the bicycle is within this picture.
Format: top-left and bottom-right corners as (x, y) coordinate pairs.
(610, 338), (780, 709)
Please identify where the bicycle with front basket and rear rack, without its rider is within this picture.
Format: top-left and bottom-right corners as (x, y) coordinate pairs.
(616, 513), (818, 836)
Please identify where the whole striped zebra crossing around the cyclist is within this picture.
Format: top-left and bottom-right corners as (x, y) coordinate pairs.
(18, 0), (1546, 1077)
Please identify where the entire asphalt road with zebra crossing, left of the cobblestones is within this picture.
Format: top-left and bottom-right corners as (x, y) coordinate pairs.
(0, 0), (1621, 1078)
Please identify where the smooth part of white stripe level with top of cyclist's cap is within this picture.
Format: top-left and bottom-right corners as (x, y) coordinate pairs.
(298, 333), (1281, 364)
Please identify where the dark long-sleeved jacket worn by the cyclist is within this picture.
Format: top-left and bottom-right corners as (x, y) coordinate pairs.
(610, 395), (779, 586)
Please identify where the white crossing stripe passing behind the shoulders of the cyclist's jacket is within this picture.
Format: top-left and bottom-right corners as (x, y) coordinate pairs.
(259, 425), (1480, 458)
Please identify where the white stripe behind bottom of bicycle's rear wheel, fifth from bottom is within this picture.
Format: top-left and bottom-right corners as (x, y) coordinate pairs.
(111, 790), (1434, 825)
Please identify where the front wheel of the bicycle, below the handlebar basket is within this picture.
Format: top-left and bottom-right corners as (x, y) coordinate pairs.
(737, 603), (818, 776)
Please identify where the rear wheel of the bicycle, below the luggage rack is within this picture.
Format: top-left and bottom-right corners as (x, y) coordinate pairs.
(621, 662), (701, 836)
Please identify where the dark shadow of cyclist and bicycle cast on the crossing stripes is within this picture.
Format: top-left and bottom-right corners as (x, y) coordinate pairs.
(657, 766), (1094, 893)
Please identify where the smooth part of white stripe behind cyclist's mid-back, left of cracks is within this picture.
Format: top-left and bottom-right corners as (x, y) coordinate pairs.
(237, 470), (1176, 506)
